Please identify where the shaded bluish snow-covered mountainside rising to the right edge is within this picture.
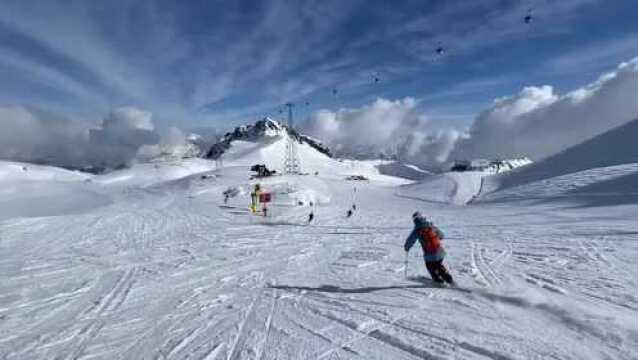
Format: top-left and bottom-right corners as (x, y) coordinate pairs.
(482, 119), (638, 203)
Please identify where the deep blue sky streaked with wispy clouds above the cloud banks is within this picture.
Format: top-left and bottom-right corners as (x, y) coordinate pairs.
(0, 0), (638, 127)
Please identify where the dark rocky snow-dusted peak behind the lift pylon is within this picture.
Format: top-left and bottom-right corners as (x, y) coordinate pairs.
(206, 117), (332, 159)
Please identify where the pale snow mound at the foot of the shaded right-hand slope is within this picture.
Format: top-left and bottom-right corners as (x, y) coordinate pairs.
(397, 171), (485, 205)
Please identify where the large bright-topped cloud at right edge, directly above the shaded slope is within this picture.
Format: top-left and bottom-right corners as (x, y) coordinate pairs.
(453, 58), (638, 160)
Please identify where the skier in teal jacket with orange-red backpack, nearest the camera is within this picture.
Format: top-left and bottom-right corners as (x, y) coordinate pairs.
(403, 211), (454, 285)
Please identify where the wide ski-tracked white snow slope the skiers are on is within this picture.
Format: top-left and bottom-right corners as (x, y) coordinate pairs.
(0, 158), (638, 360)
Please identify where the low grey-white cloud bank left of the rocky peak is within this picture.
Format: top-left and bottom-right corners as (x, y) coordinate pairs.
(0, 106), (196, 170)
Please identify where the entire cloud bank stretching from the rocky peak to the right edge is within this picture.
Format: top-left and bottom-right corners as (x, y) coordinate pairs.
(305, 58), (638, 170)
